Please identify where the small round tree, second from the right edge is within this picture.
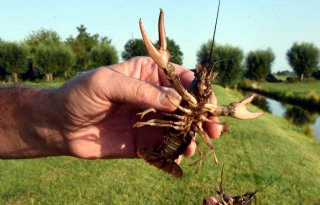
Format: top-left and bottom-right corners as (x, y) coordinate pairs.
(246, 48), (275, 81)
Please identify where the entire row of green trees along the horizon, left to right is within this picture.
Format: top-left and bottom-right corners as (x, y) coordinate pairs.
(0, 25), (320, 85)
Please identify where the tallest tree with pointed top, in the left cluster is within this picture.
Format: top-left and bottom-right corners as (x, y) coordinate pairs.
(67, 25), (99, 71)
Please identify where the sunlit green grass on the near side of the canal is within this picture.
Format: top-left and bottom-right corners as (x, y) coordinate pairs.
(0, 86), (320, 205)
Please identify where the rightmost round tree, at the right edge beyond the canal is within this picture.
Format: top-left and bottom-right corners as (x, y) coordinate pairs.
(287, 43), (319, 81)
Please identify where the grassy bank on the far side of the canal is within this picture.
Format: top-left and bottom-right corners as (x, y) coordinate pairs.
(240, 80), (320, 110)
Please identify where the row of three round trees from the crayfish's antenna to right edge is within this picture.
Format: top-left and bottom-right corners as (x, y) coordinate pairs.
(197, 40), (320, 85)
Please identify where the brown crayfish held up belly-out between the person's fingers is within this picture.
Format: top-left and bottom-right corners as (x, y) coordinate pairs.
(134, 2), (263, 178)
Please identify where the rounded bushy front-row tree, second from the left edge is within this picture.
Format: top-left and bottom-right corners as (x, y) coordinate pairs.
(35, 44), (74, 81)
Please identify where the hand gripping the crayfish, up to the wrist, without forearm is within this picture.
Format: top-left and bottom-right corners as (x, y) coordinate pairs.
(56, 57), (221, 159)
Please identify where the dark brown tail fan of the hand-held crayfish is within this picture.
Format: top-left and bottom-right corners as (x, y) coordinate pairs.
(137, 148), (183, 178)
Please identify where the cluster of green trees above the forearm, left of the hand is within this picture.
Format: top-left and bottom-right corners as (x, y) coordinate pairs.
(0, 25), (118, 81)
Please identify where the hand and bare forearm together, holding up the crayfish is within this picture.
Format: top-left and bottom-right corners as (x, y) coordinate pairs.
(0, 57), (220, 159)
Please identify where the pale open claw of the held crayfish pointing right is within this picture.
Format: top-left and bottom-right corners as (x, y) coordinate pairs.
(230, 94), (264, 120)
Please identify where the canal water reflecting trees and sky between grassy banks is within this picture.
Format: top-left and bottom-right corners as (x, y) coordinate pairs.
(252, 95), (320, 142)
